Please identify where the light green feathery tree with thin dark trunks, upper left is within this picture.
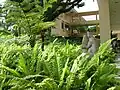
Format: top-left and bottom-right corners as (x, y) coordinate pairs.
(4, 0), (54, 50)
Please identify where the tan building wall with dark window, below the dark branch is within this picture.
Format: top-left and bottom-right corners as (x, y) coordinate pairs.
(51, 13), (85, 37)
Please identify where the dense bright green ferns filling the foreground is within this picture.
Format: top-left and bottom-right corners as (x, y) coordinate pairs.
(0, 34), (119, 90)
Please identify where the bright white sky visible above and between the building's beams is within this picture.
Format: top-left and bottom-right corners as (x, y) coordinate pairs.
(0, 0), (98, 20)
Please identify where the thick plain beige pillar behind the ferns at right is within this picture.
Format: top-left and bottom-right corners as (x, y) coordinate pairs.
(98, 0), (111, 43)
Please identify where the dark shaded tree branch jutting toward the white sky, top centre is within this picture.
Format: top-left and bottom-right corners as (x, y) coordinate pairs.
(44, 0), (84, 21)
